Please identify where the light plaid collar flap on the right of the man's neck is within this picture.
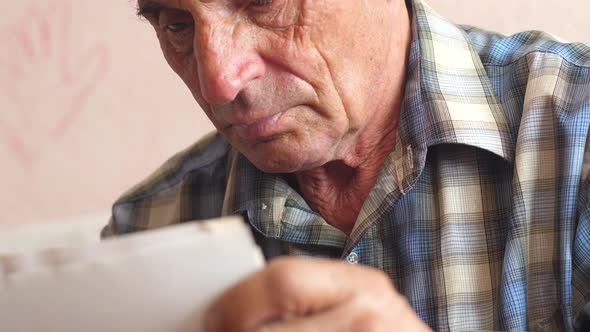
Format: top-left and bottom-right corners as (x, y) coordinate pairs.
(398, 0), (514, 162)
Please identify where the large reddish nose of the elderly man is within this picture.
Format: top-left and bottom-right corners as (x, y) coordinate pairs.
(194, 23), (265, 105)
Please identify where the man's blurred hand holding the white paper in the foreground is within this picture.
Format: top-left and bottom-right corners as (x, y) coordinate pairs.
(205, 258), (429, 332)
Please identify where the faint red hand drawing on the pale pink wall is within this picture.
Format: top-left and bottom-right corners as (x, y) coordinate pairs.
(0, 0), (109, 170)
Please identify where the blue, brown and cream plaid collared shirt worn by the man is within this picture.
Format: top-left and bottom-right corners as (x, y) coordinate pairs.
(103, 0), (590, 331)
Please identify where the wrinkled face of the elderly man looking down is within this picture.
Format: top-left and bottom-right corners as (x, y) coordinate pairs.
(139, 0), (403, 173)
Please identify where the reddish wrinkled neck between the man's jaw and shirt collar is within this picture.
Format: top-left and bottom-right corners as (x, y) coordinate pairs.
(295, 4), (411, 235)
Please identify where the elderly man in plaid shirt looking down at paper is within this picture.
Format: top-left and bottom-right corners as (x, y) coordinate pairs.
(103, 0), (590, 331)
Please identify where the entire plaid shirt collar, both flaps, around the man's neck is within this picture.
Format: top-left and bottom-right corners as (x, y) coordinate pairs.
(223, 0), (514, 241)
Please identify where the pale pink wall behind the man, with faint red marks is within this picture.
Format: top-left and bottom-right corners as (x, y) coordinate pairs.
(0, 0), (590, 227)
